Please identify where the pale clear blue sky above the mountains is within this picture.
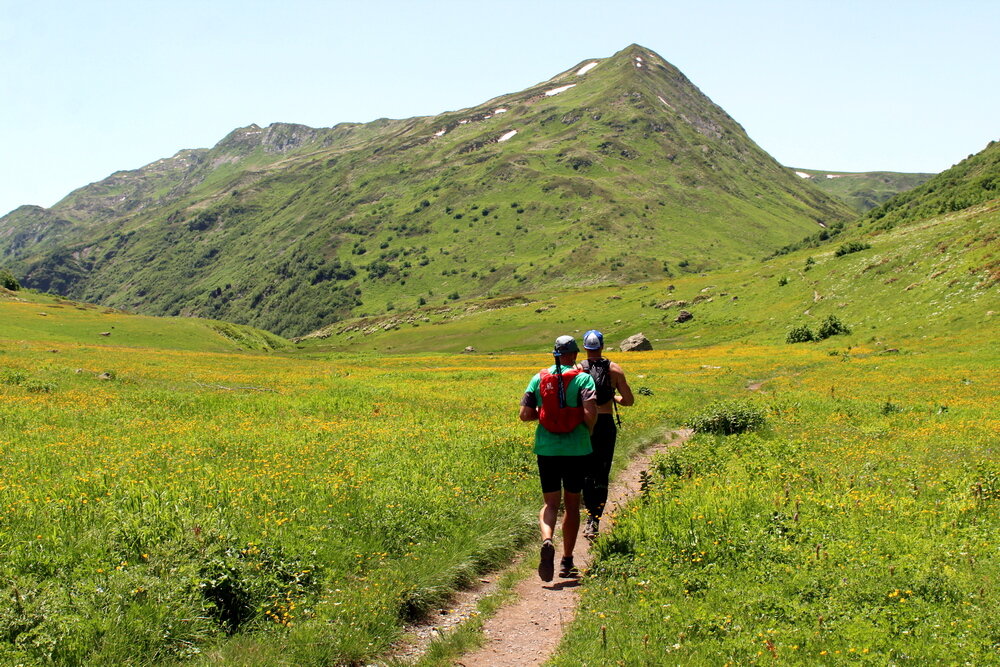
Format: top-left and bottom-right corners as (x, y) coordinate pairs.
(0, 0), (1000, 214)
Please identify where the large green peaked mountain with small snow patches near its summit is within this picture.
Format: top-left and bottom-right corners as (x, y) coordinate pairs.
(0, 45), (851, 335)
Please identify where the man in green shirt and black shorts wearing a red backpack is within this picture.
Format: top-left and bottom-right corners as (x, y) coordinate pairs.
(520, 336), (597, 581)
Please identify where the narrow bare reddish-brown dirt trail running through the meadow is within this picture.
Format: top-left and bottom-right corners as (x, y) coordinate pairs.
(448, 430), (691, 667)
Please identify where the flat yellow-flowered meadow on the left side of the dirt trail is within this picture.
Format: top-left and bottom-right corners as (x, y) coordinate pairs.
(0, 294), (715, 665)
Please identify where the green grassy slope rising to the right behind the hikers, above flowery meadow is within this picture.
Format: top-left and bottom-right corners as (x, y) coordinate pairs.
(292, 198), (1000, 352)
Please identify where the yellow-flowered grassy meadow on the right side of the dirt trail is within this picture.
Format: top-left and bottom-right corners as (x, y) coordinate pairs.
(553, 332), (1000, 665)
